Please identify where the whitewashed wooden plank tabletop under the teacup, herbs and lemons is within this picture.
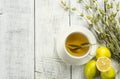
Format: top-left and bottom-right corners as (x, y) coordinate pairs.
(0, 0), (119, 79)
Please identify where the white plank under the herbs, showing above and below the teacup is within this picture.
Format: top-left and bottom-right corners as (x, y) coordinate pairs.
(70, 0), (104, 79)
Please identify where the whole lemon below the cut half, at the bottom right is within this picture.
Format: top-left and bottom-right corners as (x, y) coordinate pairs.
(101, 67), (116, 79)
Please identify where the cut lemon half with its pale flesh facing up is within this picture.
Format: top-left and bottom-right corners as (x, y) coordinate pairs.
(96, 57), (111, 72)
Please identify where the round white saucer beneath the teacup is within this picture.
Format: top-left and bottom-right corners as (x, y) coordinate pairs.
(56, 27), (97, 65)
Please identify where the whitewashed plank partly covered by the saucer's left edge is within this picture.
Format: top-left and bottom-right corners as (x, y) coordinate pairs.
(35, 0), (70, 79)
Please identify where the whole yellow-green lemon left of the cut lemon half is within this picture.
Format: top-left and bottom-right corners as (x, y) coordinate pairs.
(84, 60), (97, 79)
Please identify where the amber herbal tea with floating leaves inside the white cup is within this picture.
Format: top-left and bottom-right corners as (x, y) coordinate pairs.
(65, 32), (89, 57)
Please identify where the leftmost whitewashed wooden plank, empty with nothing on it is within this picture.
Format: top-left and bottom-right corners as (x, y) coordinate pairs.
(0, 0), (34, 79)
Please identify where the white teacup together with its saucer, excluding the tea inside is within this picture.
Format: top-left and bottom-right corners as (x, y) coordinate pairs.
(57, 27), (97, 65)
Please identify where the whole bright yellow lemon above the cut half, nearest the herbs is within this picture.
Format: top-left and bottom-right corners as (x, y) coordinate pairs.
(96, 46), (111, 59)
